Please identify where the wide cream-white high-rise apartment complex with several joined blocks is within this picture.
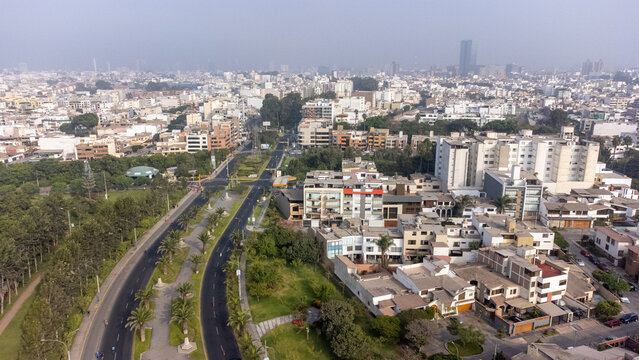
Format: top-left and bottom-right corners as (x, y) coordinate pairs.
(435, 126), (599, 193)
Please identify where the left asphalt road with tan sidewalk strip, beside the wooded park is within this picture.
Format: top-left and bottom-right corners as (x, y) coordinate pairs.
(80, 153), (242, 360)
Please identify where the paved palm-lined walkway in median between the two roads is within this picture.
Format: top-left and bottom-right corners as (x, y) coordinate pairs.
(142, 195), (235, 360)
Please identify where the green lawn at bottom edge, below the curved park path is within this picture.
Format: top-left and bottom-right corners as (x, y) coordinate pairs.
(262, 324), (333, 360)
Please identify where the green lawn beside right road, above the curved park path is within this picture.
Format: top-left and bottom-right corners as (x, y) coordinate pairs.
(247, 259), (340, 323)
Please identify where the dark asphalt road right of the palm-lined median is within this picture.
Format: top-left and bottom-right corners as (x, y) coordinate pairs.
(200, 140), (285, 360)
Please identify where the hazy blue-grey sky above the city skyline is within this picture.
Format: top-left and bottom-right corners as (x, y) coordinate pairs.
(0, 0), (639, 70)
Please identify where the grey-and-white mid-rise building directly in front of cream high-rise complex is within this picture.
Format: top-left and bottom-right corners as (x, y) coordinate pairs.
(484, 165), (543, 221)
